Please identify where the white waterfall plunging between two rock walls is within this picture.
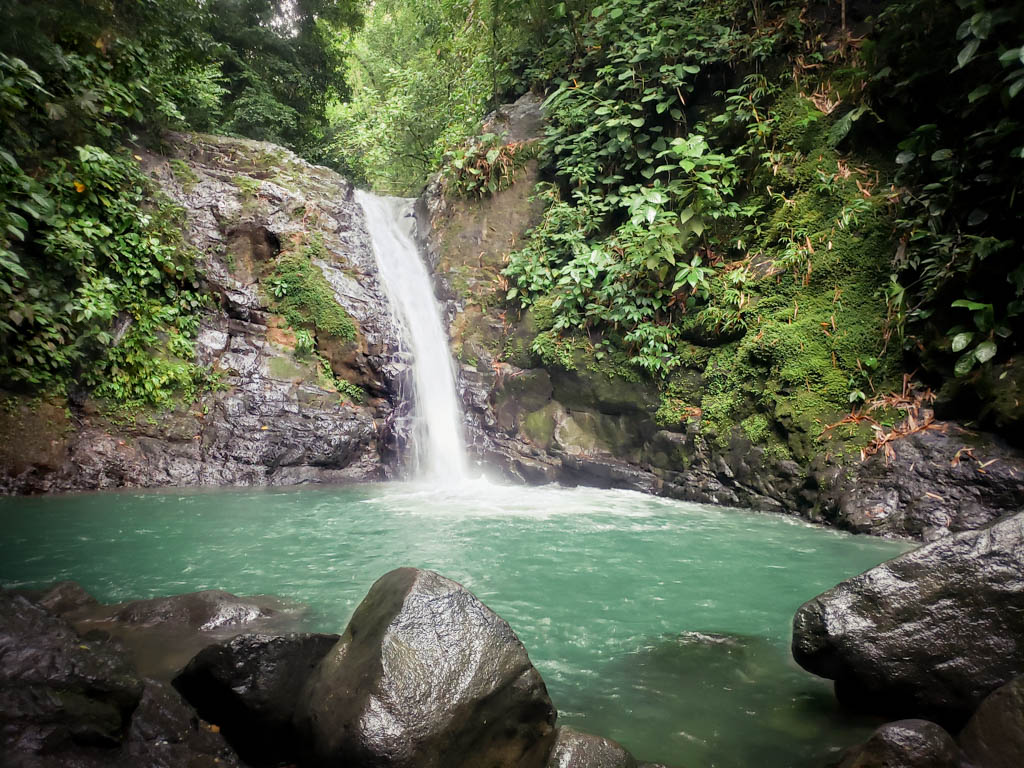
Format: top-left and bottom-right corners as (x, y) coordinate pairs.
(355, 189), (466, 480)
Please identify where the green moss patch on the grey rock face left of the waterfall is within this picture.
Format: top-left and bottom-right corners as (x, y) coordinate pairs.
(265, 241), (355, 340)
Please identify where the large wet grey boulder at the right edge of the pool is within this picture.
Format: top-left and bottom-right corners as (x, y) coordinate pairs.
(793, 513), (1024, 729)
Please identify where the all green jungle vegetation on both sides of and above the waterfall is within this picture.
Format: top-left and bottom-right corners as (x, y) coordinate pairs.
(0, 0), (1024, 444)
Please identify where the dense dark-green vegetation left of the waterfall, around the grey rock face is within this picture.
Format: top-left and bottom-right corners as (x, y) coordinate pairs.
(0, 0), (358, 404)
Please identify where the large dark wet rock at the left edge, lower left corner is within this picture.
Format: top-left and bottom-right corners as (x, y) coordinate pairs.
(0, 592), (142, 753)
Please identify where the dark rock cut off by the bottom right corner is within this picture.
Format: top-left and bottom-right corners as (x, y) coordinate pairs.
(959, 676), (1024, 768)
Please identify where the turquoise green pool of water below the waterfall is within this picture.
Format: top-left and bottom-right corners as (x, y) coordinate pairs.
(0, 481), (906, 768)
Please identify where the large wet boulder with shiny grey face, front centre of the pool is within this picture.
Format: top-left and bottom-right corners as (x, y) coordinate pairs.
(296, 568), (555, 768)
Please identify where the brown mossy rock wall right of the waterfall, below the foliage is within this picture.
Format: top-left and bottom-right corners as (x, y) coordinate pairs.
(417, 95), (1024, 538)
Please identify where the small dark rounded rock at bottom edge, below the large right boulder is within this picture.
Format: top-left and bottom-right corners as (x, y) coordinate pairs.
(838, 720), (959, 768)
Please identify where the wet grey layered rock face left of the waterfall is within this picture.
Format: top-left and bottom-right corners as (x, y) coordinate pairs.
(0, 134), (407, 493)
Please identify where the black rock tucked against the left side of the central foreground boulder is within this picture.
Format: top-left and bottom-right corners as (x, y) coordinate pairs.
(174, 634), (339, 765)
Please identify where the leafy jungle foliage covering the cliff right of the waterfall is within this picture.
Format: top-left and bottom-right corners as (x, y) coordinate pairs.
(489, 0), (1024, 444)
